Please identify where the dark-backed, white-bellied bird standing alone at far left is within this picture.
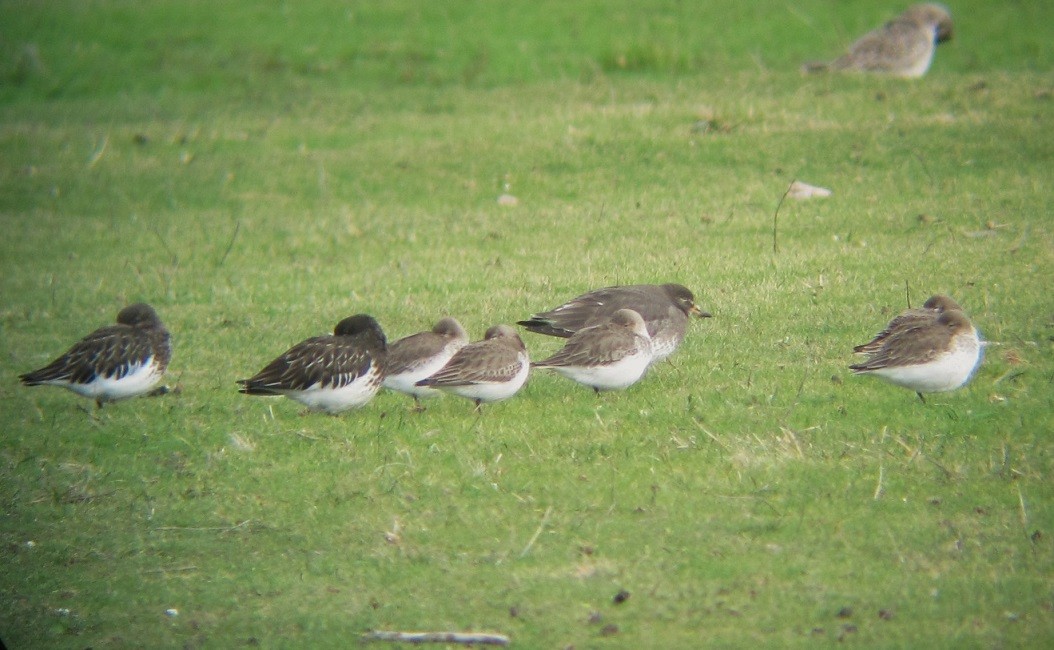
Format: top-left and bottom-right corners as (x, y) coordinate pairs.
(18, 302), (172, 409)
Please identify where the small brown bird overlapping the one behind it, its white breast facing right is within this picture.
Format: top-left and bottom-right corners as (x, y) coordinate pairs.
(415, 324), (530, 411)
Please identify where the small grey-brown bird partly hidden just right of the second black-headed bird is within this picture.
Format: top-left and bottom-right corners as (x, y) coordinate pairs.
(384, 317), (468, 409)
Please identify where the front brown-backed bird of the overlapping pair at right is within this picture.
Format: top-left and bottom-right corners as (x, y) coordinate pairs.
(850, 310), (982, 403)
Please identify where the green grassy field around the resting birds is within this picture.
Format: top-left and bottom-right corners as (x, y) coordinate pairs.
(0, 0), (1054, 649)
